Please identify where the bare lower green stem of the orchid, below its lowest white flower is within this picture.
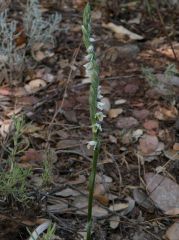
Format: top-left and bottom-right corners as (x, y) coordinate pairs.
(86, 140), (99, 240)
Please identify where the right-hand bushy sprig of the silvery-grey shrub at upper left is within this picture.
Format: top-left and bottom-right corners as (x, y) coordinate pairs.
(23, 0), (61, 47)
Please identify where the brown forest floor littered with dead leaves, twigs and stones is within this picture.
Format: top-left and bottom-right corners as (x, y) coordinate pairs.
(0, 0), (179, 240)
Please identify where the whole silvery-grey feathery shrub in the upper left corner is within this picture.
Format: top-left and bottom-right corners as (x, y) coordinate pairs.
(0, 0), (61, 84)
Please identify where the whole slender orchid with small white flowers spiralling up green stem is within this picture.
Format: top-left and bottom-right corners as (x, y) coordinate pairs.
(82, 3), (105, 240)
